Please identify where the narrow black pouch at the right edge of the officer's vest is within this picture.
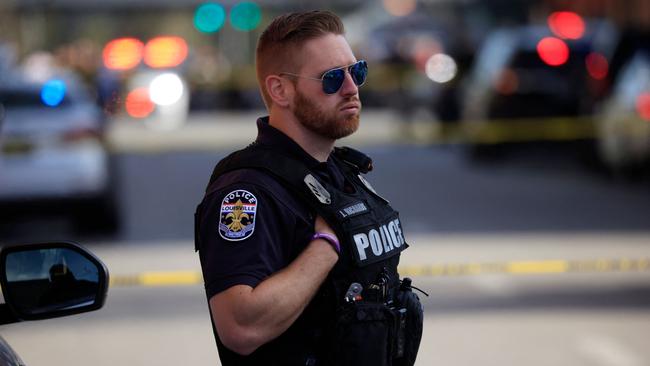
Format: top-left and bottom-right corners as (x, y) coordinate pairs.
(393, 278), (424, 366)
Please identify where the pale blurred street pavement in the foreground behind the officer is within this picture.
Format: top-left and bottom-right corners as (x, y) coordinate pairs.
(2, 234), (650, 366)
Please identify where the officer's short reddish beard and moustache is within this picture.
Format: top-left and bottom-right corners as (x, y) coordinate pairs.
(293, 89), (359, 140)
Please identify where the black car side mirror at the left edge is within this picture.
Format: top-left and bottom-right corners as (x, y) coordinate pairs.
(0, 242), (108, 323)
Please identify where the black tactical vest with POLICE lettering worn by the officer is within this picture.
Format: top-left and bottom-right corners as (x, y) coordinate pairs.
(197, 143), (422, 366)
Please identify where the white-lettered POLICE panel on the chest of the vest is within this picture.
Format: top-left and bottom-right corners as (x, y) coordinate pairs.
(352, 218), (408, 267)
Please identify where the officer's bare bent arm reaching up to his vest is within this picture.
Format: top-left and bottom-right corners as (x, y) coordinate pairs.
(210, 239), (338, 354)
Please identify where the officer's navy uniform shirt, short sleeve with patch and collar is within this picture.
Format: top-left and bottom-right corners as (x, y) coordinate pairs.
(198, 117), (345, 299)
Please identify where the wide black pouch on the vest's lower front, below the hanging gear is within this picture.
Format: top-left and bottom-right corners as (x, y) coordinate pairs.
(333, 302), (396, 366)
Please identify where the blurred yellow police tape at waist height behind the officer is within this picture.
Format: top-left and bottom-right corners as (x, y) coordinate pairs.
(110, 258), (650, 286)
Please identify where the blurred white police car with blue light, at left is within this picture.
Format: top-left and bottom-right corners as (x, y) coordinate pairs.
(0, 76), (115, 230)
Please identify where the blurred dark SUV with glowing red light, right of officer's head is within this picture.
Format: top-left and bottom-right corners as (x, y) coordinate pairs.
(462, 22), (616, 150)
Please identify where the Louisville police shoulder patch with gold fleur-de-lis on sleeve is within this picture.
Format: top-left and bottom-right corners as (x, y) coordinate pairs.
(219, 189), (257, 241)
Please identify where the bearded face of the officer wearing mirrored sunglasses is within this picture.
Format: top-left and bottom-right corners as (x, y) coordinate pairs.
(291, 34), (361, 140)
